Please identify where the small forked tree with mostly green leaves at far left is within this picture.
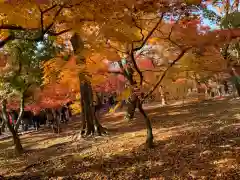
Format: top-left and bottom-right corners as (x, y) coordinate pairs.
(1, 32), (58, 154)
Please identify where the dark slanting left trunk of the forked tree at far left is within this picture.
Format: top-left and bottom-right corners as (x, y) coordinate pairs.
(2, 99), (23, 155)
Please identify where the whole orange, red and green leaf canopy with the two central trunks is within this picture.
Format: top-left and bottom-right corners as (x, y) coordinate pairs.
(0, 0), (240, 155)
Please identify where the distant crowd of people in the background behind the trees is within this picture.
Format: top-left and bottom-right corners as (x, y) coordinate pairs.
(3, 81), (232, 136)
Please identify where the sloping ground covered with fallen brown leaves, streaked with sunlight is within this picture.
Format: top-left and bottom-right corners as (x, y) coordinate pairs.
(0, 100), (240, 180)
